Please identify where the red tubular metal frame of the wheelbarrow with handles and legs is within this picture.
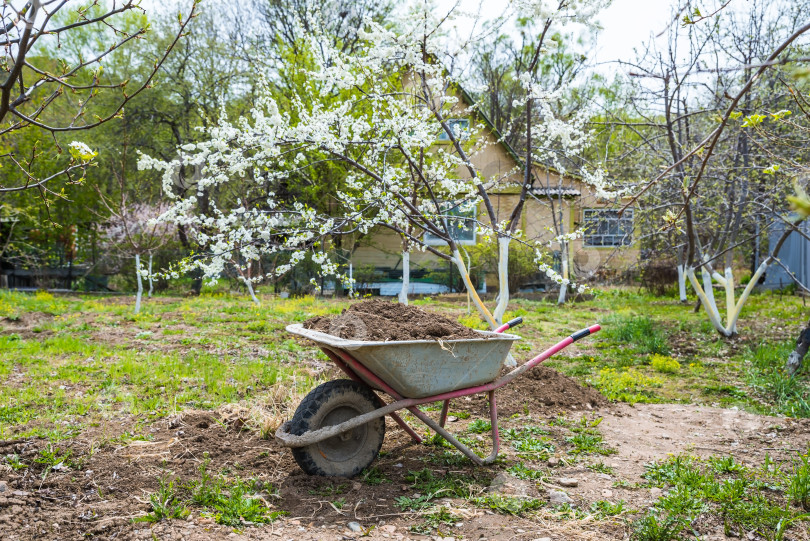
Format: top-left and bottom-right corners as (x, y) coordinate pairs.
(275, 318), (601, 466)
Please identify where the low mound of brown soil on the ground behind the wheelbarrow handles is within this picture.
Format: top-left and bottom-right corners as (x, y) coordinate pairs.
(459, 366), (609, 415)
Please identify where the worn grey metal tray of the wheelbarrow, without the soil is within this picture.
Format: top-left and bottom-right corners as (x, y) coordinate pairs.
(287, 324), (520, 398)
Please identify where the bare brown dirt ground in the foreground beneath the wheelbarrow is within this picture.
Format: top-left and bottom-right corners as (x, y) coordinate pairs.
(0, 398), (810, 541)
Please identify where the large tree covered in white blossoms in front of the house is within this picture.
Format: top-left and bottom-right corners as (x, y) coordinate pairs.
(139, 0), (606, 328)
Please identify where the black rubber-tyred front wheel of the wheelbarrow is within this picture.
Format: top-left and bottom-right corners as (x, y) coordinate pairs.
(289, 379), (385, 477)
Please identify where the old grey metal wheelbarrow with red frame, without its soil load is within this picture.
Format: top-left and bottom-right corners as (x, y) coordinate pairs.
(275, 318), (600, 477)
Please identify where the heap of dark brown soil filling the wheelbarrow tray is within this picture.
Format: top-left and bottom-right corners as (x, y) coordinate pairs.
(304, 299), (481, 342)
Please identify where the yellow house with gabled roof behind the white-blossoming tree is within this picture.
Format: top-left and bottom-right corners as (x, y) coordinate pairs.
(344, 89), (639, 295)
